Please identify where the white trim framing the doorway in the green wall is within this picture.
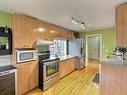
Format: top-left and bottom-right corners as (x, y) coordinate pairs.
(86, 34), (102, 61)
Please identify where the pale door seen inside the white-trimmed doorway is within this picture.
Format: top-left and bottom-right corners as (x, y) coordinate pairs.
(88, 36), (100, 60)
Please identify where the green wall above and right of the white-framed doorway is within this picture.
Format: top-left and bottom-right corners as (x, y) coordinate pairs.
(80, 28), (116, 58)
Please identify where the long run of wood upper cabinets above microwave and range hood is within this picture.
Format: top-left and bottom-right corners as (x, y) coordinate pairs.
(12, 14), (74, 48)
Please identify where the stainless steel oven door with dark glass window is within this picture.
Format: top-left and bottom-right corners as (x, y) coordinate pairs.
(43, 60), (59, 81)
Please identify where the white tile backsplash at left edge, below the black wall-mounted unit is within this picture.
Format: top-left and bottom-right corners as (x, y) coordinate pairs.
(0, 55), (11, 66)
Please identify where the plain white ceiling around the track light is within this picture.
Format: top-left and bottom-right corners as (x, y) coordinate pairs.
(0, 0), (127, 31)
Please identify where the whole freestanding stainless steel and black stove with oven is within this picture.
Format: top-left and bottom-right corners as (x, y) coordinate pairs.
(39, 51), (60, 90)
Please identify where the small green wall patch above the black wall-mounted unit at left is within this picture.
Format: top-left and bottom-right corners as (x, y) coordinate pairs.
(0, 11), (12, 27)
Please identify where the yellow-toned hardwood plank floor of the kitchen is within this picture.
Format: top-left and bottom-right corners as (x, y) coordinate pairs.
(25, 61), (100, 95)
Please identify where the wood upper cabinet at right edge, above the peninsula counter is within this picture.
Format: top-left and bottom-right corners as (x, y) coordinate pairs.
(116, 3), (127, 46)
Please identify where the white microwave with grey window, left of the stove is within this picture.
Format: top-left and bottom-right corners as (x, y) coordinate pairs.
(16, 48), (38, 63)
